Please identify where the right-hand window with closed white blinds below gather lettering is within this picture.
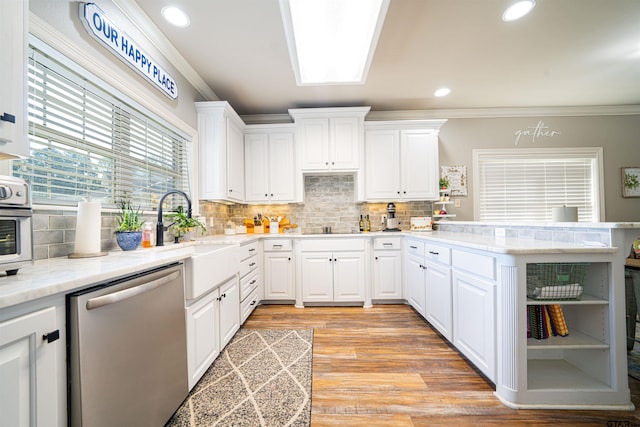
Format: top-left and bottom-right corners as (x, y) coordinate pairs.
(473, 148), (604, 222)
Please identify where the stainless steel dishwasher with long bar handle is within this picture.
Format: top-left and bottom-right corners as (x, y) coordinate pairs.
(67, 264), (189, 426)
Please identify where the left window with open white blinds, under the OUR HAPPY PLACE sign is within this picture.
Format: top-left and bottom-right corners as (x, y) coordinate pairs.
(13, 42), (191, 210)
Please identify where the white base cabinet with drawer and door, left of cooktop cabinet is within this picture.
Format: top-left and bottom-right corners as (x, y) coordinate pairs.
(264, 239), (296, 301)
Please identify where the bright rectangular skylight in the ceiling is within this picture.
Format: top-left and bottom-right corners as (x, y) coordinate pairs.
(280, 0), (389, 86)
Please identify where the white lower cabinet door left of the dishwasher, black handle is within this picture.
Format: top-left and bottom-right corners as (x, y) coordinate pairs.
(0, 307), (58, 426)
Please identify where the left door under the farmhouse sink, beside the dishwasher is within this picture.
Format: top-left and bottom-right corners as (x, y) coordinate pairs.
(186, 290), (220, 390)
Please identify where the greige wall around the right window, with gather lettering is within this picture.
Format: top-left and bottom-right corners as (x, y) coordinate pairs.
(440, 115), (640, 222)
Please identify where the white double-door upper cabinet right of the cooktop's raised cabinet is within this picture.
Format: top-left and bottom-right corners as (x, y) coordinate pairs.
(365, 120), (445, 201)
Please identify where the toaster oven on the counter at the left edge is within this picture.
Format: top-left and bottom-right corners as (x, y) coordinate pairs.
(0, 176), (33, 276)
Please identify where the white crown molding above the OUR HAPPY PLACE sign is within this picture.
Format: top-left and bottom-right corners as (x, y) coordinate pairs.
(112, 0), (220, 101)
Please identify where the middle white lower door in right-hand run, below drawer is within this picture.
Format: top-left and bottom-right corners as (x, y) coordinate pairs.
(425, 263), (453, 341)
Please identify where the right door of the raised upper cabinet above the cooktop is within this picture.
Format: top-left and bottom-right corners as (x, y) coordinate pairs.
(329, 117), (360, 170)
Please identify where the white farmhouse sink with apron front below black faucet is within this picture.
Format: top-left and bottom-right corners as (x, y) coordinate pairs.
(184, 244), (240, 300)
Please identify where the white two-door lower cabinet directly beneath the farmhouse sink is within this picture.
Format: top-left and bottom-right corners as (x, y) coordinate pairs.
(186, 276), (240, 390)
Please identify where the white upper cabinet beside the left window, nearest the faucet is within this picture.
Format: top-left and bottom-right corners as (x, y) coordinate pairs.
(196, 101), (245, 202)
